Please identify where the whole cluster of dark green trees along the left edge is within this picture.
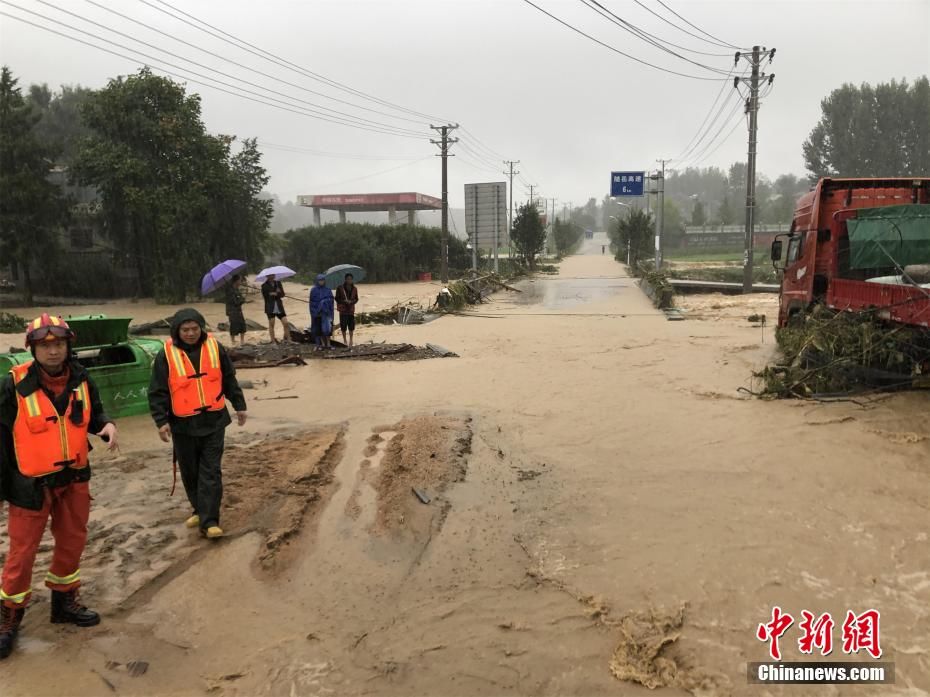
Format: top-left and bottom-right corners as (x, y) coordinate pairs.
(0, 67), (272, 303)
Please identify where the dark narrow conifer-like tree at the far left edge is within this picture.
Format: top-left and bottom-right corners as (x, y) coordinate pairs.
(0, 66), (68, 305)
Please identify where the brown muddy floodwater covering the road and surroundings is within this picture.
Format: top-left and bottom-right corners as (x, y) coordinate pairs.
(0, 237), (930, 697)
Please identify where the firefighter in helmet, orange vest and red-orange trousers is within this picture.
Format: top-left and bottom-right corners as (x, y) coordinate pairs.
(0, 313), (117, 658)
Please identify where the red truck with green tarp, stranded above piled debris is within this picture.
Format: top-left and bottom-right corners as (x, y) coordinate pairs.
(772, 177), (930, 327)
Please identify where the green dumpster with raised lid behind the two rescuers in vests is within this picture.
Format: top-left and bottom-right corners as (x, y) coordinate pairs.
(0, 315), (164, 418)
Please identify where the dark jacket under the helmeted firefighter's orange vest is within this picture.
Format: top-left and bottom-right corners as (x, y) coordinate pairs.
(0, 359), (113, 511)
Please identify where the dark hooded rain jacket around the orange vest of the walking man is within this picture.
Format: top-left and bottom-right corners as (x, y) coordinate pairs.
(149, 308), (246, 436)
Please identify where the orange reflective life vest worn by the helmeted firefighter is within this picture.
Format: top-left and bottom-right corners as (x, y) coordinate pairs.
(10, 361), (90, 477)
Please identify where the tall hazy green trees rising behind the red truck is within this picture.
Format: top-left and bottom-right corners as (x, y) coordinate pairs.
(803, 76), (930, 180)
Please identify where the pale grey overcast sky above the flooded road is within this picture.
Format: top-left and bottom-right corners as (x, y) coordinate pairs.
(0, 0), (930, 206)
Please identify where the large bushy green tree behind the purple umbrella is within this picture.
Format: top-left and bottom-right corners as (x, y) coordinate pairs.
(73, 68), (269, 303)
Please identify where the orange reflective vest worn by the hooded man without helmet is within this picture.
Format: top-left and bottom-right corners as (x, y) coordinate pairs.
(165, 334), (226, 418)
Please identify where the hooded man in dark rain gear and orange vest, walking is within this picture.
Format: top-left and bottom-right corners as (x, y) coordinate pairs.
(149, 308), (246, 539)
